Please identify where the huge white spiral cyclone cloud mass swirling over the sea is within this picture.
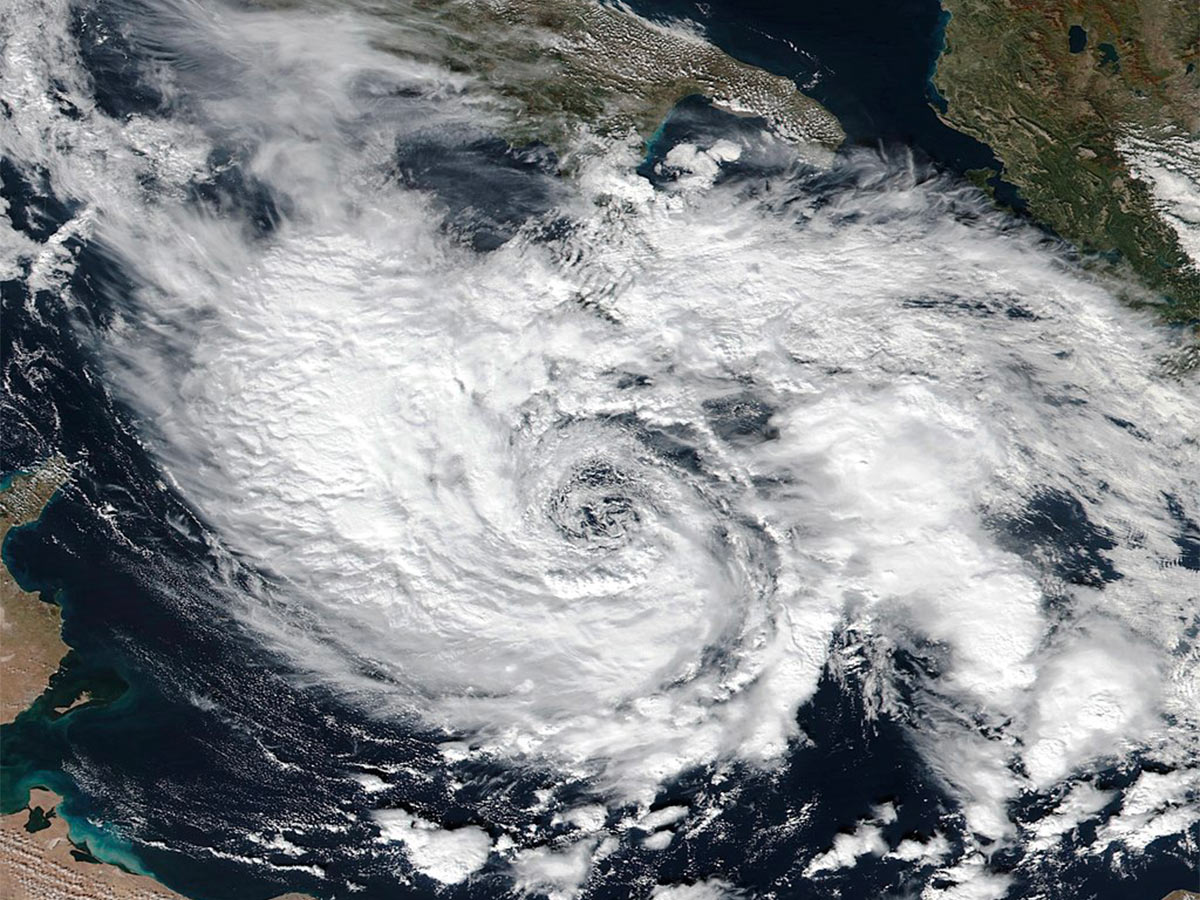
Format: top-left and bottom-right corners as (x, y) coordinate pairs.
(6, 2), (1200, 896)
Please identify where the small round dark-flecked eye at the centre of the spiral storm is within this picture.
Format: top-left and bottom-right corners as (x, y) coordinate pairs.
(548, 460), (641, 550)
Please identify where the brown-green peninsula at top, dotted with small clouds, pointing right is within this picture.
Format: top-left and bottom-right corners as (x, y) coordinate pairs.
(328, 0), (845, 156)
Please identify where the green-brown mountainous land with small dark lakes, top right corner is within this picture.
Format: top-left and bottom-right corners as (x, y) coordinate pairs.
(935, 0), (1200, 323)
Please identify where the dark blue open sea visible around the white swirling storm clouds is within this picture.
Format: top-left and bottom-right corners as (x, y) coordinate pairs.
(0, 0), (1194, 900)
